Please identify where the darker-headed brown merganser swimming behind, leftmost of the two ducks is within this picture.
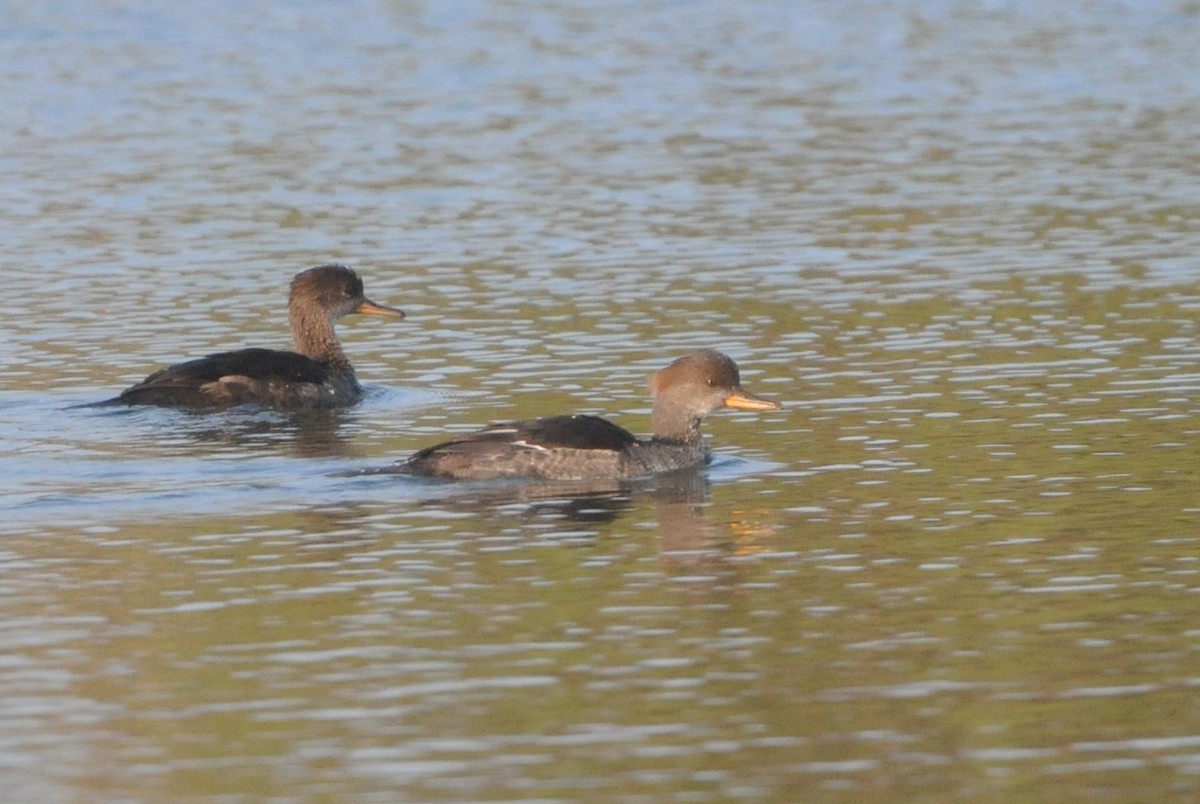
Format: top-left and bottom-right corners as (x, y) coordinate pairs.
(88, 264), (404, 409)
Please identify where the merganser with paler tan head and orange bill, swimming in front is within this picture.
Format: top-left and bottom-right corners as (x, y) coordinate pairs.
(374, 349), (782, 480)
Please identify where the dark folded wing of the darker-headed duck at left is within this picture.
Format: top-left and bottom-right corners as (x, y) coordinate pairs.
(110, 349), (330, 406)
